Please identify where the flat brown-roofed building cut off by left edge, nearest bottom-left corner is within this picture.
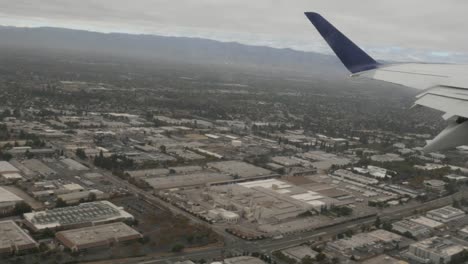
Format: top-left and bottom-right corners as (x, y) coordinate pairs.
(0, 220), (38, 254)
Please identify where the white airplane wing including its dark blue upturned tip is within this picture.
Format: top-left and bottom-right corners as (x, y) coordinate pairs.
(305, 12), (468, 152)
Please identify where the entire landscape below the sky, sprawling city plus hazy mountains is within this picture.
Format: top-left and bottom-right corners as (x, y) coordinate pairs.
(0, 2), (468, 264)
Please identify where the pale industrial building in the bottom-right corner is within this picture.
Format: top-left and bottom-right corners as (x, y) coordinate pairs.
(406, 236), (464, 264)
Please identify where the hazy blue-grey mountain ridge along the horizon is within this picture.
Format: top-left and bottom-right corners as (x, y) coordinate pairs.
(0, 26), (345, 75)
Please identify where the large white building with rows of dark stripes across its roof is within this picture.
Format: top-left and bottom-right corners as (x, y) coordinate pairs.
(24, 201), (134, 232)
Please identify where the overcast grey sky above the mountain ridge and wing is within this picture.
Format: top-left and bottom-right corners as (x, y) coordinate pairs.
(0, 0), (468, 63)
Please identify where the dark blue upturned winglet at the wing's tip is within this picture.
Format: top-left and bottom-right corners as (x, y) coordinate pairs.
(305, 12), (379, 73)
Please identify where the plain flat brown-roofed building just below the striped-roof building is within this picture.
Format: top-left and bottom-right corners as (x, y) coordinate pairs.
(55, 222), (143, 251)
